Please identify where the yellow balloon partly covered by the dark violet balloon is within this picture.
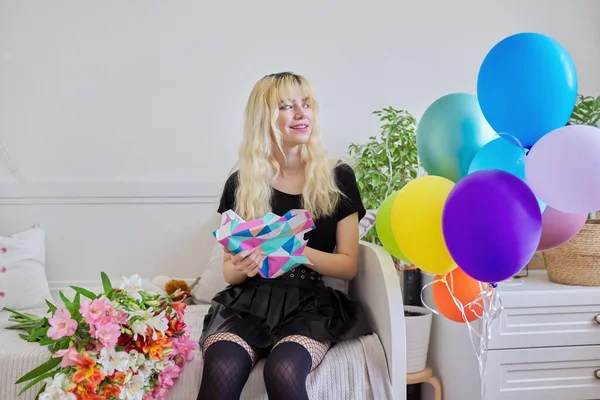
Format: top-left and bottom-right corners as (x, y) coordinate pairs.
(391, 175), (456, 276)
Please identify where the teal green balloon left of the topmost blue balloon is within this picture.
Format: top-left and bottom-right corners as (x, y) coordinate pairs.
(417, 93), (496, 182)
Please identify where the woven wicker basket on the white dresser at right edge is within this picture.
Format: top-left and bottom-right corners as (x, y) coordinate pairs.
(542, 219), (600, 286)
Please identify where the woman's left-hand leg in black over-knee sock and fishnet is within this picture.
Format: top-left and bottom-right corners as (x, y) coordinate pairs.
(197, 332), (258, 400)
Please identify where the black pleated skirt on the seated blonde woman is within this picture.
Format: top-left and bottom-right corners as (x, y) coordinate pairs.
(200, 276), (373, 350)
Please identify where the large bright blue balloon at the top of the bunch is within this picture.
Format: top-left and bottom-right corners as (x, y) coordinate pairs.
(477, 33), (578, 148)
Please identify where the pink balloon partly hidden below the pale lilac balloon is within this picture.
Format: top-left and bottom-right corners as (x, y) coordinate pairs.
(537, 206), (588, 251)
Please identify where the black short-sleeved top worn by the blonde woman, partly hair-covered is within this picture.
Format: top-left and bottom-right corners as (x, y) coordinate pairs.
(218, 163), (366, 253)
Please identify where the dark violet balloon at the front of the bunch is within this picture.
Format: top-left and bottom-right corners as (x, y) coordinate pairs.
(442, 169), (542, 283)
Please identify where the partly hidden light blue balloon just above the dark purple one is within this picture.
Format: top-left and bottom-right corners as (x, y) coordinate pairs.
(469, 136), (546, 212)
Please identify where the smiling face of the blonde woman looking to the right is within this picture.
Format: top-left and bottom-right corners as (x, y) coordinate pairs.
(277, 89), (313, 148)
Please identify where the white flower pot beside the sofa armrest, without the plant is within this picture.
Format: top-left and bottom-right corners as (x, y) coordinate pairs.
(404, 306), (433, 374)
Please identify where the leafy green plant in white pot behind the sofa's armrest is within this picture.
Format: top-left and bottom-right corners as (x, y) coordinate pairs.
(348, 107), (432, 373)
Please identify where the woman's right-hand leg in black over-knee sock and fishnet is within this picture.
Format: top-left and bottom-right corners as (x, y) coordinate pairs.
(263, 335), (330, 400)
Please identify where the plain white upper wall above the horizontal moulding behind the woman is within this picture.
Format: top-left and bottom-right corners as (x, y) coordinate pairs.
(0, 0), (600, 181)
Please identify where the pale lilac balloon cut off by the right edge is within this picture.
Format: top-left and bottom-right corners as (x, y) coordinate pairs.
(525, 125), (600, 213)
